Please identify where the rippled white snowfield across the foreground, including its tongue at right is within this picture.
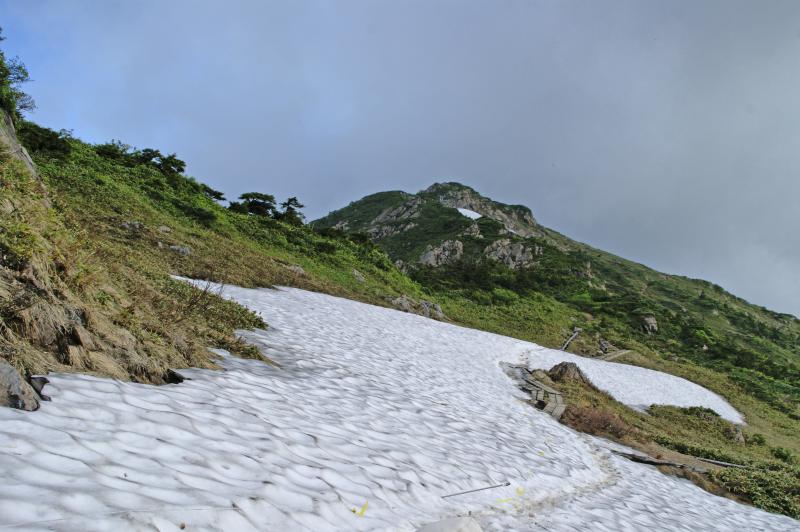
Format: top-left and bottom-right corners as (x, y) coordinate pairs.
(0, 287), (798, 531)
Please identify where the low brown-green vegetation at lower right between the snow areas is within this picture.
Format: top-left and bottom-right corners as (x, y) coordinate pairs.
(552, 372), (800, 518)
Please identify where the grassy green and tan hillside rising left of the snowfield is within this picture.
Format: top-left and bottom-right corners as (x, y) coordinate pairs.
(0, 122), (428, 382)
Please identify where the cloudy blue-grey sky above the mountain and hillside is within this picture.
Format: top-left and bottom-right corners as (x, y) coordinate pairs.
(0, 0), (800, 316)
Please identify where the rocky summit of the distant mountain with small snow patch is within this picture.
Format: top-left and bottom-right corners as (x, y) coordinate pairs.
(314, 183), (552, 269)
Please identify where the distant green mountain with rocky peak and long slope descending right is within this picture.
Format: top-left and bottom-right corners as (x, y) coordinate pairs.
(313, 183), (800, 419)
